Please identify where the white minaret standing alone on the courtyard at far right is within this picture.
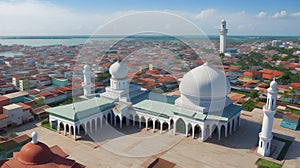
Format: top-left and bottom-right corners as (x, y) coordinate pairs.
(257, 78), (278, 156)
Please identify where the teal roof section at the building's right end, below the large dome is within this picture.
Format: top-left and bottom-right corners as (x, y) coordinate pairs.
(206, 104), (243, 121)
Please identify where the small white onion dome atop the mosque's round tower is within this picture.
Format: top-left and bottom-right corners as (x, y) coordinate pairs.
(109, 61), (128, 79)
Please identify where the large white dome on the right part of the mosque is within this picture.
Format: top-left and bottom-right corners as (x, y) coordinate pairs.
(179, 63), (230, 100)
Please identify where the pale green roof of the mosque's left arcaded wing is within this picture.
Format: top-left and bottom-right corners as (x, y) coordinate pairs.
(46, 97), (115, 121)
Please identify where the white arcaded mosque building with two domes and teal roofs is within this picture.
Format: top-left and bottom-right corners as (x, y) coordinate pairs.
(46, 62), (242, 141)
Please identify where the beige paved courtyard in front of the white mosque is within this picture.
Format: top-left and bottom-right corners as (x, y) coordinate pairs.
(7, 109), (300, 168)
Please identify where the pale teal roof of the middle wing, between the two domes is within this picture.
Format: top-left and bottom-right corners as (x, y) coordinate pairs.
(132, 99), (176, 118)
